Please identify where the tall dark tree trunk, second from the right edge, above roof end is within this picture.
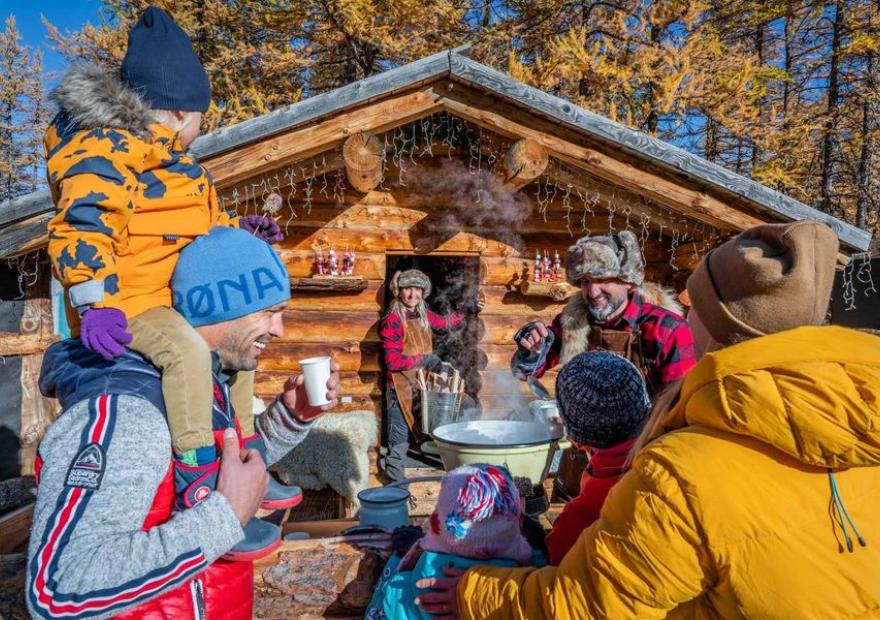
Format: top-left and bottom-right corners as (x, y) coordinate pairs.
(820, 0), (844, 217)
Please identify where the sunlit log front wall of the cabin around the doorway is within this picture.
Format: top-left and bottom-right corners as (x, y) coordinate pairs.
(246, 158), (690, 438)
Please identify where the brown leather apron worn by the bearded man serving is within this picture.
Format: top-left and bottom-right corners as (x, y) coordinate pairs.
(553, 325), (657, 501)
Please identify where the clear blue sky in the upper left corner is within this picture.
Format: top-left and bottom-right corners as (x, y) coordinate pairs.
(0, 0), (104, 78)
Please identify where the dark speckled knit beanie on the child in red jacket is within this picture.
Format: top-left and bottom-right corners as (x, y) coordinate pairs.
(556, 351), (651, 449)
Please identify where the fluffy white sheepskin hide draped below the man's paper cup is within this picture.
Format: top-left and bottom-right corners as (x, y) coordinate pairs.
(272, 411), (379, 506)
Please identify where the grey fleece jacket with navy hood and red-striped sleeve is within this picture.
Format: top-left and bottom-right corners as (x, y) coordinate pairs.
(26, 340), (310, 618)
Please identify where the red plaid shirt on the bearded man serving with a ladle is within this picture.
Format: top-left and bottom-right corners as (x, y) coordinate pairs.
(535, 293), (697, 391)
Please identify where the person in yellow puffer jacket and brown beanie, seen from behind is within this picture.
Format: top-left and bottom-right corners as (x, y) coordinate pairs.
(418, 221), (880, 620)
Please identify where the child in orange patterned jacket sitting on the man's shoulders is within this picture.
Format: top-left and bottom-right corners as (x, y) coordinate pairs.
(44, 7), (292, 556)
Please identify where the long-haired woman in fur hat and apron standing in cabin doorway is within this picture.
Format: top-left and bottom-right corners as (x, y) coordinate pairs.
(379, 269), (483, 481)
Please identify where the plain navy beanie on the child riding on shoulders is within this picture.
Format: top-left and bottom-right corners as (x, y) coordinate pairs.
(120, 6), (211, 112)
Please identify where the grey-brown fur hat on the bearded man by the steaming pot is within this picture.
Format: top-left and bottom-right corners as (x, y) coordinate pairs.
(565, 230), (645, 286)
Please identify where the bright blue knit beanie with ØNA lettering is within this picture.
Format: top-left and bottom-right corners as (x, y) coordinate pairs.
(171, 226), (290, 327)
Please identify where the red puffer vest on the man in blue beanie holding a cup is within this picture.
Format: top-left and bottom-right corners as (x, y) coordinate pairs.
(34, 432), (254, 620)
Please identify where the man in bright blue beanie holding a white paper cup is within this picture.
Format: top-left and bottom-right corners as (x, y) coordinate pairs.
(27, 227), (339, 620)
